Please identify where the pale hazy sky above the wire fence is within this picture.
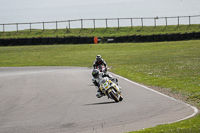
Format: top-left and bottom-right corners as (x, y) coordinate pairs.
(0, 0), (200, 30)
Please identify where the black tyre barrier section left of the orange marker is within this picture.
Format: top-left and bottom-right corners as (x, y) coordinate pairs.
(0, 37), (94, 46)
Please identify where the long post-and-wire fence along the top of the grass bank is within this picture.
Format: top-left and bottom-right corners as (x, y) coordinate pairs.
(0, 15), (200, 32)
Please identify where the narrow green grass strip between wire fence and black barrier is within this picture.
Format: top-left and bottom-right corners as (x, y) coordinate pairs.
(0, 24), (200, 38)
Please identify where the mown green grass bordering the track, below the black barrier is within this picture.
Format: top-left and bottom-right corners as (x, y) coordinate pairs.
(0, 40), (200, 133)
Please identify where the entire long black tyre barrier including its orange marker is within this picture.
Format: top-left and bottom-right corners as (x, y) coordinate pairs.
(0, 32), (200, 46)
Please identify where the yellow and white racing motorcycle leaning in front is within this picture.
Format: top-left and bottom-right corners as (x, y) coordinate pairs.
(100, 77), (123, 102)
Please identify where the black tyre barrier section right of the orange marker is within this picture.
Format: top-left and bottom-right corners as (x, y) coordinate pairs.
(104, 32), (200, 43)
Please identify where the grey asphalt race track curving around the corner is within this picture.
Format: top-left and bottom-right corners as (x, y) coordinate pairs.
(0, 67), (198, 133)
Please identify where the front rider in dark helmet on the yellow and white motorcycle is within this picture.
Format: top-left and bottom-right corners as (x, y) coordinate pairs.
(92, 69), (121, 98)
